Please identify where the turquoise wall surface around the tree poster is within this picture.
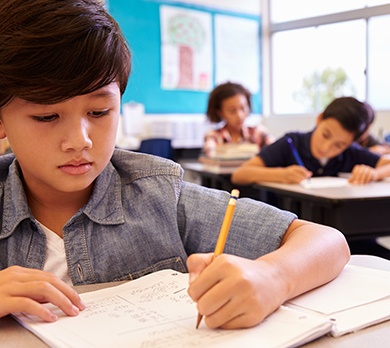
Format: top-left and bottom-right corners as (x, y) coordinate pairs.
(108, 0), (261, 114)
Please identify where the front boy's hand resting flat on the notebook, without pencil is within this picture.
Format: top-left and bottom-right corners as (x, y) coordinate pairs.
(0, 266), (85, 322)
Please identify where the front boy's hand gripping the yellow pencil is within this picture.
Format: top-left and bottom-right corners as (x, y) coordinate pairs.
(187, 254), (286, 329)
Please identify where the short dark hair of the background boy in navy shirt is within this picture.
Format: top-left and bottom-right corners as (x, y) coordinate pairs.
(322, 97), (370, 140)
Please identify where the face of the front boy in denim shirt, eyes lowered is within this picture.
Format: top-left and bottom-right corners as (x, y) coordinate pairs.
(0, 83), (120, 197)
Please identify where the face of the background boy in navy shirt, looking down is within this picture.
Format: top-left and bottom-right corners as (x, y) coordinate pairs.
(310, 115), (354, 160)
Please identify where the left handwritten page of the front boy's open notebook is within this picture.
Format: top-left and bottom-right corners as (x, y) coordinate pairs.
(15, 270), (332, 348)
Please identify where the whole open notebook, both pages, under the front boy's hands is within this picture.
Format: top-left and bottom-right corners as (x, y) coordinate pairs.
(14, 266), (390, 348)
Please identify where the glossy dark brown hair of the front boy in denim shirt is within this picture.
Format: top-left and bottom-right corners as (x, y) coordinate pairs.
(0, 0), (131, 107)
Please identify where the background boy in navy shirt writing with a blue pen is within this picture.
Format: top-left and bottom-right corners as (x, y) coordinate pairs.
(231, 97), (390, 185)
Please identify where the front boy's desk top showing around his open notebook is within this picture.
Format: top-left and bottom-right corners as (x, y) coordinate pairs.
(0, 283), (390, 348)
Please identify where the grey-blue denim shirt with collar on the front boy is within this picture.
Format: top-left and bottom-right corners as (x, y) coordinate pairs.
(0, 150), (296, 285)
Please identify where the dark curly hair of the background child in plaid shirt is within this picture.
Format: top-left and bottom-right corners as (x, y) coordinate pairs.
(206, 82), (252, 123)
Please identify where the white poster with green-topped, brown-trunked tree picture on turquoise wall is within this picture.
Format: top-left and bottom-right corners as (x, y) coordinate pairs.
(160, 5), (213, 91)
